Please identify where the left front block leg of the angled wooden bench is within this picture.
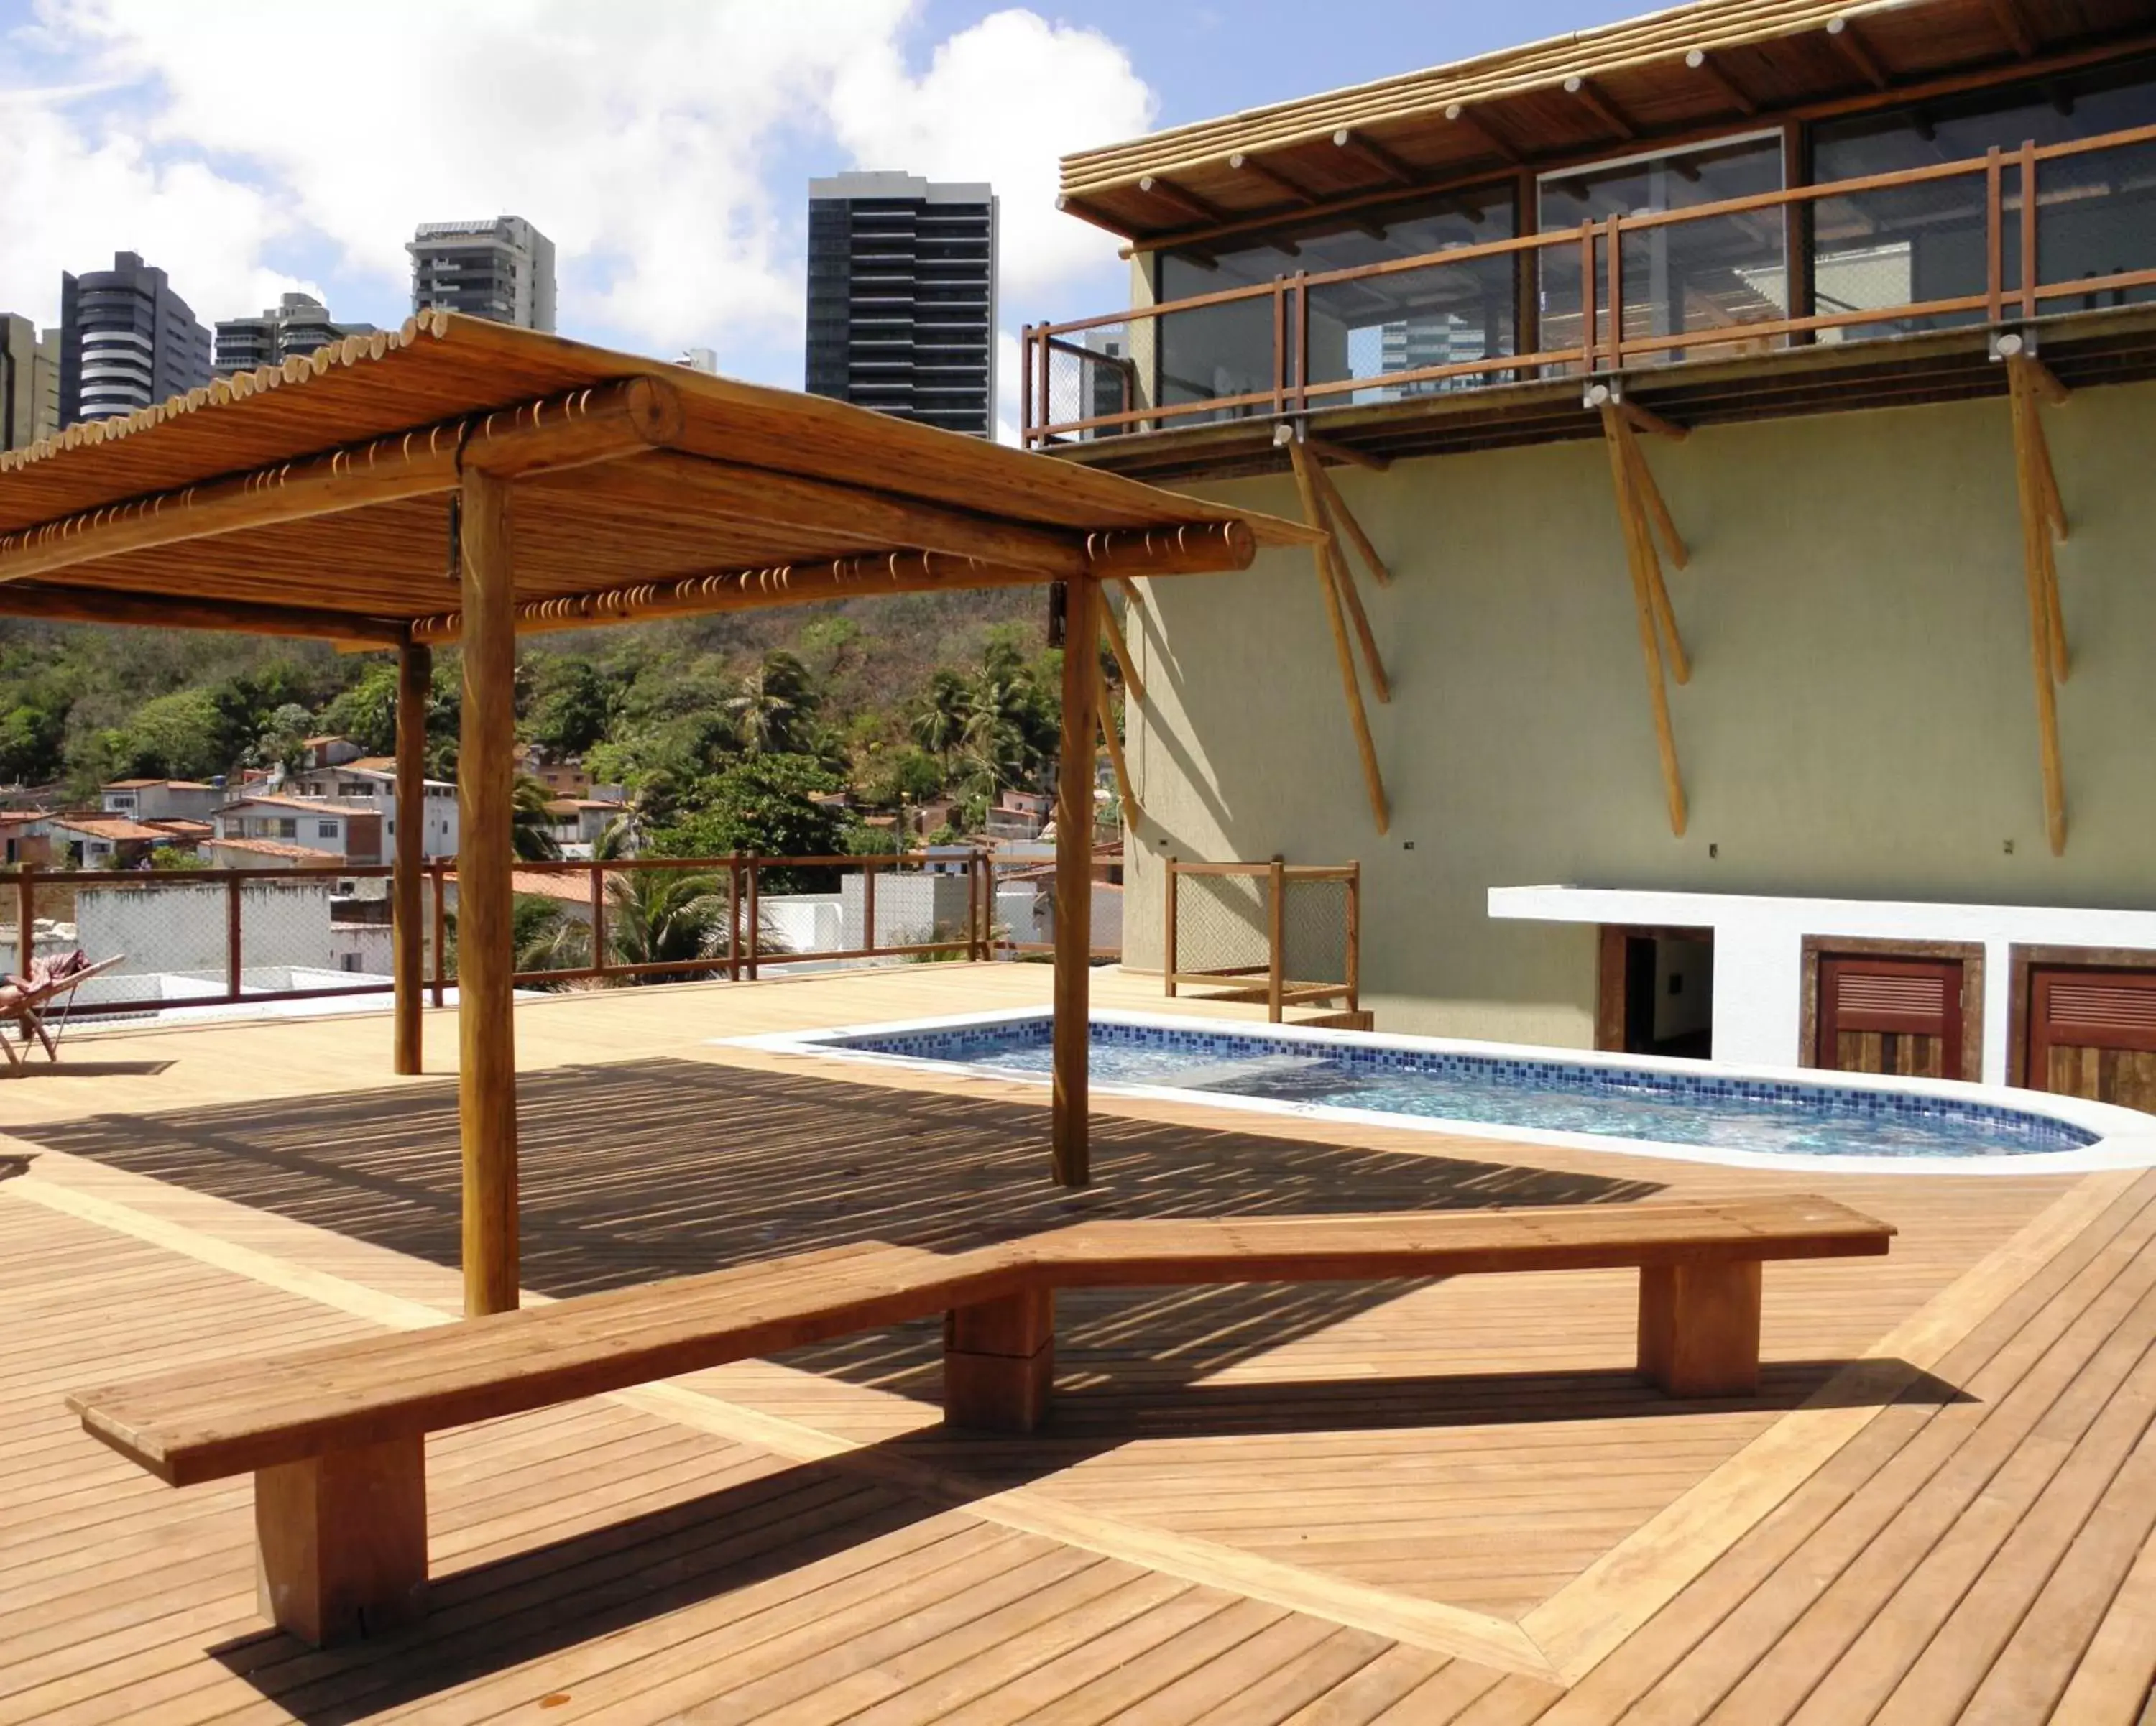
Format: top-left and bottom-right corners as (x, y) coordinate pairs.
(254, 1435), (427, 1648)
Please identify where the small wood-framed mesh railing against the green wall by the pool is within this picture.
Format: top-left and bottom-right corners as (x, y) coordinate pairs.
(1162, 858), (1363, 1023)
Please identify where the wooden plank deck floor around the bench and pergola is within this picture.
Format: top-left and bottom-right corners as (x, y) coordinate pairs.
(0, 965), (2156, 1726)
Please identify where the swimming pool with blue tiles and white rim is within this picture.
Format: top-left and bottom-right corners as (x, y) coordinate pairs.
(740, 1010), (2156, 1172)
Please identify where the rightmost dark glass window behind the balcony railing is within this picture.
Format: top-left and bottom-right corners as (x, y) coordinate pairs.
(1811, 60), (2156, 341)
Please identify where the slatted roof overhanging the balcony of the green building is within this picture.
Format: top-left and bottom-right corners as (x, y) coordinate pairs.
(1063, 0), (2156, 244)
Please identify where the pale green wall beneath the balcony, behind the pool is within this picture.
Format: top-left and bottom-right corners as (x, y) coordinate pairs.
(1128, 386), (2156, 1045)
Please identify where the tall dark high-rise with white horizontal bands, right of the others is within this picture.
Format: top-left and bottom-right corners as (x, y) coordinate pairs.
(808, 175), (996, 438)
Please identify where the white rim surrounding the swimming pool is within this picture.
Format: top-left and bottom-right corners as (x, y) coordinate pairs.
(711, 1006), (2156, 1176)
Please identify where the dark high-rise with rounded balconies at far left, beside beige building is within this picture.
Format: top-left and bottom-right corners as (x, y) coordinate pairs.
(60, 252), (209, 427)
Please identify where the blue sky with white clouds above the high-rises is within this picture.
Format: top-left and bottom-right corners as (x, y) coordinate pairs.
(0, 0), (1647, 435)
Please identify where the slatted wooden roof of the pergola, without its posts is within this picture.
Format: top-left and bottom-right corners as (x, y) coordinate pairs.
(0, 313), (1309, 636)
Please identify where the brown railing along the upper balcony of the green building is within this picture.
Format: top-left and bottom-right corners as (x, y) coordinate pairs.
(1020, 125), (2156, 446)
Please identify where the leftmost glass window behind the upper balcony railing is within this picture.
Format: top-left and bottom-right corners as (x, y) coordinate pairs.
(1164, 185), (1518, 425)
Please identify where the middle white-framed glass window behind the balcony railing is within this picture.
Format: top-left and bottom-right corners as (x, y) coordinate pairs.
(1539, 131), (1789, 364)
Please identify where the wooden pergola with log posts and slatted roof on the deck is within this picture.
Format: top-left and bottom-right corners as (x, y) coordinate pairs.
(0, 313), (1317, 1314)
